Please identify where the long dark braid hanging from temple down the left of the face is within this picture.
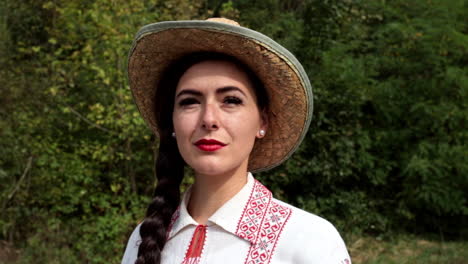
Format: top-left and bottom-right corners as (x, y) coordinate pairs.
(135, 51), (185, 264)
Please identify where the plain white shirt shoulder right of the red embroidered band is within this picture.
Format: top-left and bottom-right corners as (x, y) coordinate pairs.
(273, 199), (351, 264)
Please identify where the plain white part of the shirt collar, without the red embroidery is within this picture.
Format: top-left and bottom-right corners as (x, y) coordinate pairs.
(167, 172), (259, 244)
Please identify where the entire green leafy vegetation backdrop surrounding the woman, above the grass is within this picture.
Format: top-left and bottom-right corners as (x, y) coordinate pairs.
(0, 0), (468, 263)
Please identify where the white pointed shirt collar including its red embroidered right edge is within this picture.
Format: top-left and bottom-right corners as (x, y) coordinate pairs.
(168, 173), (280, 244)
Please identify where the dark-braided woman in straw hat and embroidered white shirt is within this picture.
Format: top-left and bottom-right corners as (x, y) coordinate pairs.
(122, 19), (350, 264)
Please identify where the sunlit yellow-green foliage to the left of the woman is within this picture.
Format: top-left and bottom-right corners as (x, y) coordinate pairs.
(0, 0), (207, 263)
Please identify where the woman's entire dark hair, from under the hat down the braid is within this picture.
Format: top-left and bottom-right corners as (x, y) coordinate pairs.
(135, 52), (268, 264)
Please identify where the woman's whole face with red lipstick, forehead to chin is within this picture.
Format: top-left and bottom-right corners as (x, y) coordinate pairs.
(172, 61), (266, 175)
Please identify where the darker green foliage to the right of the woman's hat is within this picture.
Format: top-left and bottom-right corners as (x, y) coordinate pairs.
(250, 1), (468, 236)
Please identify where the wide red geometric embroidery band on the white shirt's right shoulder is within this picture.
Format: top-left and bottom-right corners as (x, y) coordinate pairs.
(236, 181), (292, 264)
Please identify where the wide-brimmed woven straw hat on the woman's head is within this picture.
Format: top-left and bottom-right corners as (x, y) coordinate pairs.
(128, 18), (312, 172)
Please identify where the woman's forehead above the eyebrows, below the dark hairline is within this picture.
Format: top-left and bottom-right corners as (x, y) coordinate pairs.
(177, 60), (255, 96)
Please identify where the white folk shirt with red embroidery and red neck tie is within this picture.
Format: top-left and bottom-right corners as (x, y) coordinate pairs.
(122, 173), (351, 264)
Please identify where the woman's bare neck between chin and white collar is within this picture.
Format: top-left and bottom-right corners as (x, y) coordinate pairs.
(187, 166), (247, 225)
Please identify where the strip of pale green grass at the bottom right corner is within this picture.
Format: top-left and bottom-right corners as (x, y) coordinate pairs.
(347, 235), (468, 264)
